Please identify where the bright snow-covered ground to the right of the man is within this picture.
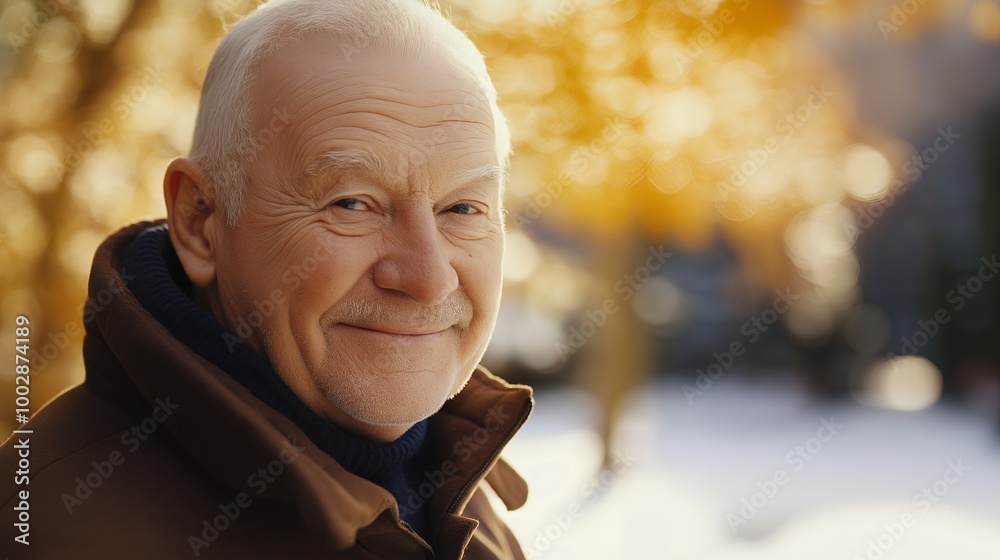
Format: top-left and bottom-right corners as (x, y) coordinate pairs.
(501, 375), (1000, 560)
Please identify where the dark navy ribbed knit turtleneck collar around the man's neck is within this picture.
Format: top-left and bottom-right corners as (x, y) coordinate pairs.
(122, 226), (427, 480)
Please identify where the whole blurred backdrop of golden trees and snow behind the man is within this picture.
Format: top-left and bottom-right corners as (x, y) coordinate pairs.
(0, 0), (1000, 560)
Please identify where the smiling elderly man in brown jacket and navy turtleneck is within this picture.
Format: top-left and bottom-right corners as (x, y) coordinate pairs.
(0, 0), (532, 559)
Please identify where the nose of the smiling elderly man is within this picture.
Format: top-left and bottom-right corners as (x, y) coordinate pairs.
(373, 213), (458, 305)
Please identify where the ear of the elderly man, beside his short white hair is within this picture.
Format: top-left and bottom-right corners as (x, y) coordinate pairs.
(163, 158), (222, 288)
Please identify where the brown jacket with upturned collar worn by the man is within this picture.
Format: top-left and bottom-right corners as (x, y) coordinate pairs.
(0, 223), (533, 560)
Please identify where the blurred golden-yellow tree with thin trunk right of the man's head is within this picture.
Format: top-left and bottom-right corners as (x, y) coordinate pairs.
(457, 0), (868, 464)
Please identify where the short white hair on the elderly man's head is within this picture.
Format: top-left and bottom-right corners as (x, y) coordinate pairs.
(190, 0), (511, 227)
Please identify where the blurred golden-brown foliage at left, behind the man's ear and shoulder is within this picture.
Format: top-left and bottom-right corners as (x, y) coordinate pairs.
(0, 0), (255, 433)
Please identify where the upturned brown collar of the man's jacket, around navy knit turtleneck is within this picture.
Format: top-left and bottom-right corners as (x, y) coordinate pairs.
(84, 221), (534, 550)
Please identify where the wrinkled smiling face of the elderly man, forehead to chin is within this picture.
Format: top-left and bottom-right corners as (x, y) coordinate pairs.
(215, 35), (504, 440)
